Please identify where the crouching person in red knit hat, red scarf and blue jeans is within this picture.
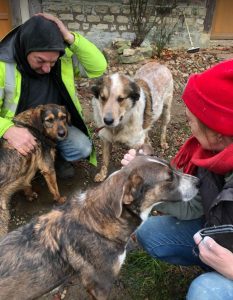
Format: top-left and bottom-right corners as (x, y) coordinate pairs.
(122, 60), (233, 300)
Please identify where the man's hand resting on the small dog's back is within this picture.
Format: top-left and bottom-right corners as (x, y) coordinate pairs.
(3, 126), (37, 155)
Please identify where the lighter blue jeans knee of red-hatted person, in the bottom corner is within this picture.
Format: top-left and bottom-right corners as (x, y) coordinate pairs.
(186, 272), (233, 300)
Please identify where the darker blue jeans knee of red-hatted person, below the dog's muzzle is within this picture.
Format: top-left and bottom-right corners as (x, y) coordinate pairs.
(136, 216), (206, 267)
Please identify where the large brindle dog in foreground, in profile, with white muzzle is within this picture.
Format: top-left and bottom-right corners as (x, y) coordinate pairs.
(0, 156), (198, 300)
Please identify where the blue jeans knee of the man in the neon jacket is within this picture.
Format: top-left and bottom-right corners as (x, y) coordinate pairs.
(57, 126), (92, 161)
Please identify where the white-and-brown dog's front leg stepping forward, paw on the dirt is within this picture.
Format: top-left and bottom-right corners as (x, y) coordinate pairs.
(94, 140), (112, 182)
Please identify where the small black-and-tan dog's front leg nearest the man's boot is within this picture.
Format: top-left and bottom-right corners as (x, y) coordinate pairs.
(41, 166), (66, 204)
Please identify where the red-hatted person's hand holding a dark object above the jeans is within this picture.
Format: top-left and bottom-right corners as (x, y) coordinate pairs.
(194, 232), (233, 280)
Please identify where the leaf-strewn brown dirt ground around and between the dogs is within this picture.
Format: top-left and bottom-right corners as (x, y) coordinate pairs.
(8, 47), (233, 300)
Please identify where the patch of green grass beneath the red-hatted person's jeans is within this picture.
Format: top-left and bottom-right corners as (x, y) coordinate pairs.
(121, 250), (201, 300)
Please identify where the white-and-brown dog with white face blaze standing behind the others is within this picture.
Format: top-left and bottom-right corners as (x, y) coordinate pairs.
(92, 62), (173, 181)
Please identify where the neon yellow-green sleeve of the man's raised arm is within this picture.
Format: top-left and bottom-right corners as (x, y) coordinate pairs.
(69, 33), (107, 78)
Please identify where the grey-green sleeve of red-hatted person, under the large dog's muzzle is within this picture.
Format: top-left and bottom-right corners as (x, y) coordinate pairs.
(155, 194), (204, 220)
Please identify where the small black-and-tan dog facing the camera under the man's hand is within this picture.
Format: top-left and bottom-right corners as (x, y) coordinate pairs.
(0, 104), (70, 236)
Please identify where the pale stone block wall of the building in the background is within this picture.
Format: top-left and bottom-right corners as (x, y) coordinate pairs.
(38, 0), (209, 49)
